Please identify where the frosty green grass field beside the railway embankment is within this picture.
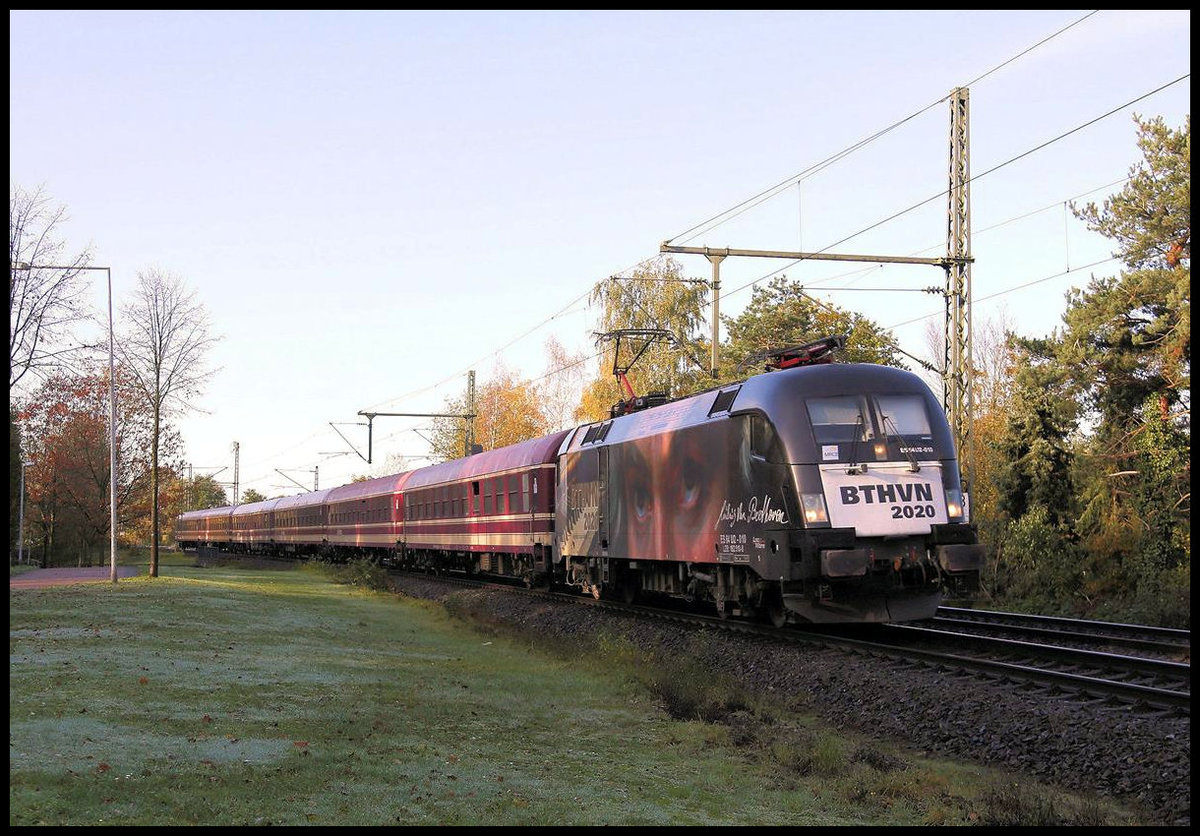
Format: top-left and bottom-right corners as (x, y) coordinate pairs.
(8, 555), (1124, 825)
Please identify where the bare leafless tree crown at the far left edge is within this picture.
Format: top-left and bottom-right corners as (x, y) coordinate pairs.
(8, 187), (91, 391)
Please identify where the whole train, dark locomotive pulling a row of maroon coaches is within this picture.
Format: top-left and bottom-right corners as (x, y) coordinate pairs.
(175, 341), (984, 627)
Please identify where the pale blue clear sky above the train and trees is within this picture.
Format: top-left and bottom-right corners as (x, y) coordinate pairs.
(8, 10), (1192, 497)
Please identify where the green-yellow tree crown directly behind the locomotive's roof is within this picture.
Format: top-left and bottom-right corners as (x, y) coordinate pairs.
(721, 276), (907, 383)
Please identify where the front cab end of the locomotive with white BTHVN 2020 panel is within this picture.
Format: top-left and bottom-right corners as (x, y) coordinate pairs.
(734, 363), (983, 623)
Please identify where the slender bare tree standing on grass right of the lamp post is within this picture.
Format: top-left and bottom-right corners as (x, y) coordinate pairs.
(118, 270), (217, 577)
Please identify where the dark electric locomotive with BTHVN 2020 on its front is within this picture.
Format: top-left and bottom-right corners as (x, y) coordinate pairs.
(556, 338), (983, 626)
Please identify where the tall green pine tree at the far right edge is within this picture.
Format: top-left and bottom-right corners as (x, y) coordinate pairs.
(1058, 116), (1192, 576)
